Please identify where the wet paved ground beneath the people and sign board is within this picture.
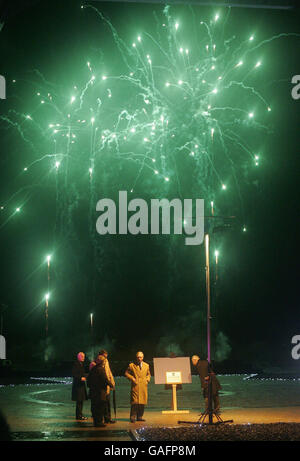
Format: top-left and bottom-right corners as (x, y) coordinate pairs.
(0, 375), (300, 441)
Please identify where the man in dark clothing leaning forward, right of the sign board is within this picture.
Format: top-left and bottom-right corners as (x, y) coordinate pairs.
(192, 355), (222, 415)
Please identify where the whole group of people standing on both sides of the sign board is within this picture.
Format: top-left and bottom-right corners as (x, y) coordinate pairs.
(72, 350), (221, 427)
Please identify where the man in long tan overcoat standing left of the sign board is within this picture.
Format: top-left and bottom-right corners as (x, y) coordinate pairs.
(125, 352), (151, 423)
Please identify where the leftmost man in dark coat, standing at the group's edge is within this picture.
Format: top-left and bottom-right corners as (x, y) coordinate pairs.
(72, 352), (87, 421)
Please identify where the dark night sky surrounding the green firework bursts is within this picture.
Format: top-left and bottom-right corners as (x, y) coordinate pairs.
(0, 0), (300, 365)
